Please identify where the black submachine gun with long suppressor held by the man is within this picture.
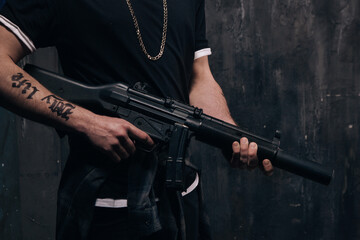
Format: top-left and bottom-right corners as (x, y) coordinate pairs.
(24, 64), (333, 190)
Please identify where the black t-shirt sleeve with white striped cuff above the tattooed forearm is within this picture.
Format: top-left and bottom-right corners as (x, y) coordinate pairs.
(0, 0), (59, 51)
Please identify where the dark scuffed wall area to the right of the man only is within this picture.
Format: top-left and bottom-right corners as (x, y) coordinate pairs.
(201, 0), (360, 240)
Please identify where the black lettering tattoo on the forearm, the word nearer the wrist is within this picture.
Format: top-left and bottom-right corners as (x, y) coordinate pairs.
(41, 95), (75, 121)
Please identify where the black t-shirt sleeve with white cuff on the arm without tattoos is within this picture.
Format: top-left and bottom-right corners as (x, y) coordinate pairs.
(195, 0), (211, 59)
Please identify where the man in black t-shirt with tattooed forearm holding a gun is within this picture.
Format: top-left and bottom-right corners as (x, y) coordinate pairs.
(0, 0), (273, 239)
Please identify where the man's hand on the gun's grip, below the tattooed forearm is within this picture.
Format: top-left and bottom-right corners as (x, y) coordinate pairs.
(84, 115), (154, 162)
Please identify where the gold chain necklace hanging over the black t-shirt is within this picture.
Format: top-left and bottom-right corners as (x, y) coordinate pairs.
(126, 0), (168, 61)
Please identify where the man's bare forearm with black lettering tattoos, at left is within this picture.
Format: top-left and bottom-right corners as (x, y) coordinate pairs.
(0, 54), (94, 136)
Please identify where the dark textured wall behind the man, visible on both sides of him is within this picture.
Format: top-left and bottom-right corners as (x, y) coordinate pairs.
(0, 0), (360, 240)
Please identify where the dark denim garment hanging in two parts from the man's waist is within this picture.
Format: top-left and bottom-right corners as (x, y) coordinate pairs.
(57, 139), (161, 240)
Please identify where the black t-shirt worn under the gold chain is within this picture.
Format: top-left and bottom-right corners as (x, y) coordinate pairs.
(0, 0), (208, 102)
